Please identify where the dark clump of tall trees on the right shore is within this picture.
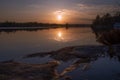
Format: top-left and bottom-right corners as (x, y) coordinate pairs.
(91, 12), (120, 35)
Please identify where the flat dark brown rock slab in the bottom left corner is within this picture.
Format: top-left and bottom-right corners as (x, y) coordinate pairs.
(0, 61), (59, 80)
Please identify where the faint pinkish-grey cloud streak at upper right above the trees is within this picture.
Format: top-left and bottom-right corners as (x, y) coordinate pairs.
(76, 3), (120, 15)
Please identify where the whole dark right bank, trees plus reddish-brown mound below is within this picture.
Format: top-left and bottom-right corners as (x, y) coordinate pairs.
(91, 12), (120, 46)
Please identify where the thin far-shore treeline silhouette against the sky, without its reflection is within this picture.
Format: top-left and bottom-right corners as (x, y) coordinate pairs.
(0, 21), (89, 27)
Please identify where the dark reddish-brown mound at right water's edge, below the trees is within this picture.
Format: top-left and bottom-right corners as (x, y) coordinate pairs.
(91, 30), (120, 57)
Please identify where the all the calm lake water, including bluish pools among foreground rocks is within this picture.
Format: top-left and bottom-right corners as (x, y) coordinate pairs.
(0, 28), (120, 80)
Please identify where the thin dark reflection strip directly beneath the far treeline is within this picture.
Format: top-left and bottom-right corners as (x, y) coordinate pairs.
(0, 26), (90, 33)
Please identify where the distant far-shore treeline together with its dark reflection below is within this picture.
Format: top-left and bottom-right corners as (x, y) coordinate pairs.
(0, 21), (91, 33)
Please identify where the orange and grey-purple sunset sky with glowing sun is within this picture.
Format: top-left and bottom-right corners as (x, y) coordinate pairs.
(0, 0), (120, 23)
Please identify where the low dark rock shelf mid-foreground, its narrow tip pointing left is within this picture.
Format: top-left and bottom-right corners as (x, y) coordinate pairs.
(24, 46), (120, 78)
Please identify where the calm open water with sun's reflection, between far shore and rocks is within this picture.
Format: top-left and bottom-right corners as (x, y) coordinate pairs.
(0, 28), (97, 60)
